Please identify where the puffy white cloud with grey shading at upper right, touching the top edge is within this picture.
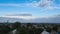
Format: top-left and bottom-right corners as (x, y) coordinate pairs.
(32, 0), (60, 10)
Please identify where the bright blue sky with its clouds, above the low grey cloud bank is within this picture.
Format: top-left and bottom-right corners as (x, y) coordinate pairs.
(0, 0), (60, 19)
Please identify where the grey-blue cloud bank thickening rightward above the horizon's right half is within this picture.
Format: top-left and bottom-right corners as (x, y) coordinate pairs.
(30, 14), (60, 23)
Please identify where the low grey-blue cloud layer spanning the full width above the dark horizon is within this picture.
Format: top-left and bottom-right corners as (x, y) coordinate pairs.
(0, 14), (60, 23)
